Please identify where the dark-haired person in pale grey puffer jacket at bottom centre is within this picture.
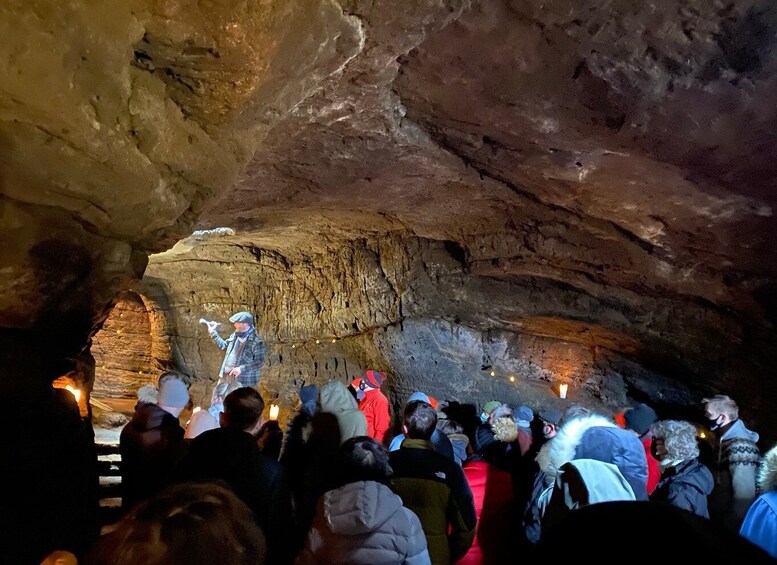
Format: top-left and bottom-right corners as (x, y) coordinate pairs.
(297, 436), (431, 565)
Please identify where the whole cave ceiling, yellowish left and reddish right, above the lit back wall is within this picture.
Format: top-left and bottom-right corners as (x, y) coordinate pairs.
(0, 0), (777, 406)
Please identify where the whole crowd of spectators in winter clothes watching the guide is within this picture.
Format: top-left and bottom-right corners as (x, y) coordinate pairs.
(39, 344), (777, 565)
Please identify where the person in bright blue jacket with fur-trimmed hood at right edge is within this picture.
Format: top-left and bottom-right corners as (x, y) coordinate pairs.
(739, 446), (777, 559)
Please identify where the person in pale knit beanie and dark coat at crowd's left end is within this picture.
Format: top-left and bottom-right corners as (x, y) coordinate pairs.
(119, 378), (189, 511)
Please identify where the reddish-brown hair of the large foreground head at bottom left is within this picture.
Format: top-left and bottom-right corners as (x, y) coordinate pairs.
(85, 483), (267, 565)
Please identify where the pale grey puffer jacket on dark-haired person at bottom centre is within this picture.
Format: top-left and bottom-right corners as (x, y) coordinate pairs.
(297, 481), (431, 565)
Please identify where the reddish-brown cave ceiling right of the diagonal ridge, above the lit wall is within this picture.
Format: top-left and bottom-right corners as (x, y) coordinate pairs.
(191, 1), (777, 372)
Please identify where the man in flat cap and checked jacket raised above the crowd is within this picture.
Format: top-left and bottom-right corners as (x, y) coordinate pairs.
(206, 312), (264, 387)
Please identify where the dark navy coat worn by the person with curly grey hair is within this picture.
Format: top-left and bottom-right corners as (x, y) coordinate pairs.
(650, 458), (713, 518)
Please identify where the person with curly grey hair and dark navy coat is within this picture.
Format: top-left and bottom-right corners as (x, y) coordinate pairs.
(650, 420), (713, 518)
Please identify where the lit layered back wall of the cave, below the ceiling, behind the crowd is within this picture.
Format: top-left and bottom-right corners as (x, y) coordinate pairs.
(144, 234), (767, 434)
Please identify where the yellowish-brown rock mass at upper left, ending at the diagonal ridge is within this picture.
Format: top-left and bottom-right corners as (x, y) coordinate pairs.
(0, 0), (363, 394)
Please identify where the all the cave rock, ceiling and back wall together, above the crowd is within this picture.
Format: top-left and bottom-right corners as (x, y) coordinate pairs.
(0, 0), (777, 438)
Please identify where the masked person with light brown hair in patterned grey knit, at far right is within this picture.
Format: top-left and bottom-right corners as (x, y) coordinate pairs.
(704, 394), (761, 532)
